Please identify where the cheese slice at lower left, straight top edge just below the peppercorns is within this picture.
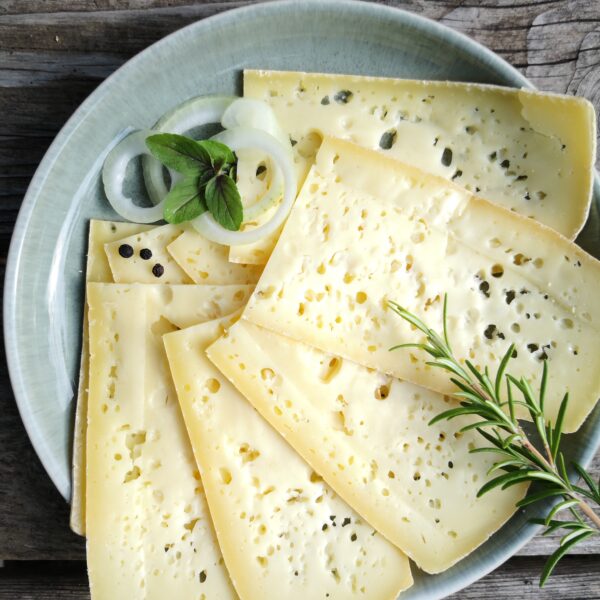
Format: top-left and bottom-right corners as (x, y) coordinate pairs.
(86, 283), (249, 600)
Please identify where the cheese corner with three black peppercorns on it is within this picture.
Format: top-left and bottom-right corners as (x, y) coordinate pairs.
(105, 225), (191, 283)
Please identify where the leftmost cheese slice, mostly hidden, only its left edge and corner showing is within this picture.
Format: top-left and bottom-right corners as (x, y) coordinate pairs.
(70, 219), (151, 535)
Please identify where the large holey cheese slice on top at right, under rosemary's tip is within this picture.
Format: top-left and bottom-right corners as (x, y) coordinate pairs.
(244, 138), (600, 432)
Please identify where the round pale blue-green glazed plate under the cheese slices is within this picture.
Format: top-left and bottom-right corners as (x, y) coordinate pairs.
(4, 1), (600, 600)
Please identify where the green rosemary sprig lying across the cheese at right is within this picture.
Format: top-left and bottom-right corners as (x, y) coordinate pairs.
(389, 296), (600, 587)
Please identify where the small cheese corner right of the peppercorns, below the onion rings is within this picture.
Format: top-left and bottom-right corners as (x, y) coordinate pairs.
(167, 229), (262, 285)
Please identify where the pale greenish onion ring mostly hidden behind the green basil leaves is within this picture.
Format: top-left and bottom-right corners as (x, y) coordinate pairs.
(142, 96), (235, 204)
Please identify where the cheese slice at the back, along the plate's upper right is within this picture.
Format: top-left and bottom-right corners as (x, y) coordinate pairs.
(232, 70), (596, 261)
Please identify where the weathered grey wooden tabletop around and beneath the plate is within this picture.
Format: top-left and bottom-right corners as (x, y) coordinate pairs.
(0, 0), (600, 600)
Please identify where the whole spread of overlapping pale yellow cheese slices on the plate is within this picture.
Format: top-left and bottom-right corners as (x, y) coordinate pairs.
(72, 71), (600, 600)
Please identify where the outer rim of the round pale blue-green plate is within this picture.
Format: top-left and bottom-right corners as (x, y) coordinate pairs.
(3, 0), (600, 600)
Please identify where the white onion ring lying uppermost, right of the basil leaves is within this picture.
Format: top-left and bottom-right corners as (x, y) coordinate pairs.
(191, 127), (297, 246)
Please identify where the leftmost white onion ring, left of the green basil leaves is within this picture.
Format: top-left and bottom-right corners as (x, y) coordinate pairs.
(102, 129), (164, 223)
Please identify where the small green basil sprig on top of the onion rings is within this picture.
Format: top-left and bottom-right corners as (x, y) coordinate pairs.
(146, 133), (244, 231)
